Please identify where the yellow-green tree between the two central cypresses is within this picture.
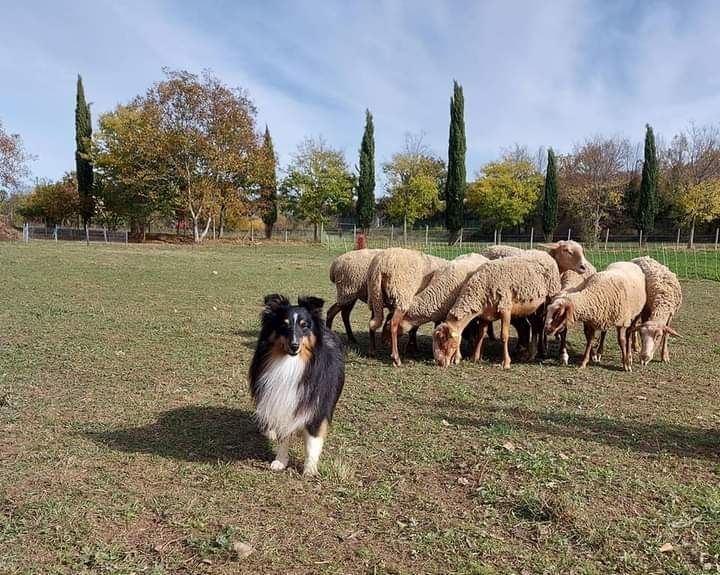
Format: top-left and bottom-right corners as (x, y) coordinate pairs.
(383, 134), (446, 241)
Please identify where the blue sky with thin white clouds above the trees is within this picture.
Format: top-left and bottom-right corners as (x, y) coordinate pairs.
(0, 0), (720, 184)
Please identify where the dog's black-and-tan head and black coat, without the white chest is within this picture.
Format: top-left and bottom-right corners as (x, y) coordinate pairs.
(250, 294), (345, 436)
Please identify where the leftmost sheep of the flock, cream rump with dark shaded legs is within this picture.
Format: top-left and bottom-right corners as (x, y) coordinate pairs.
(326, 248), (382, 344)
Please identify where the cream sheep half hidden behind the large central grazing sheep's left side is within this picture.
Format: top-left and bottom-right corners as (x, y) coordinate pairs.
(376, 254), (489, 362)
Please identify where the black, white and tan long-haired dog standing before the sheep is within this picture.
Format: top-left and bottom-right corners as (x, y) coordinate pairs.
(250, 294), (345, 475)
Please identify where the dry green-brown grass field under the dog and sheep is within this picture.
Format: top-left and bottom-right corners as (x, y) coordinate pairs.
(0, 242), (720, 574)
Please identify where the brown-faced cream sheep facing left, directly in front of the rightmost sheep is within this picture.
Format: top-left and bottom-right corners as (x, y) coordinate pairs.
(545, 262), (646, 371)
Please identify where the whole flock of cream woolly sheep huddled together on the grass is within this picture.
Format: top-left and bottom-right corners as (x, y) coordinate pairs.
(327, 241), (682, 371)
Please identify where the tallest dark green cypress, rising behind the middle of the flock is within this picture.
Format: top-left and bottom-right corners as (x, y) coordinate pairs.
(445, 81), (467, 244)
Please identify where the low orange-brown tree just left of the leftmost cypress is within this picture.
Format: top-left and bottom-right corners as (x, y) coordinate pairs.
(17, 173), (81, 227)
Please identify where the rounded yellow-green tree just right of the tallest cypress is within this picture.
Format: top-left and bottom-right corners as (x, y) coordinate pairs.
(467, 160), (543, 236)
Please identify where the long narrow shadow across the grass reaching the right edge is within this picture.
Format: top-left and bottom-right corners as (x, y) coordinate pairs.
(436, 406), (720, 460)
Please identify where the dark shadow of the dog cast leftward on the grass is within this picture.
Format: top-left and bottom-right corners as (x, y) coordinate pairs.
(86, 406), (272, 462)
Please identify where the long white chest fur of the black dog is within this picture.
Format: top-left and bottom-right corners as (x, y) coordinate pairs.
(255, 355), (305, 439)
